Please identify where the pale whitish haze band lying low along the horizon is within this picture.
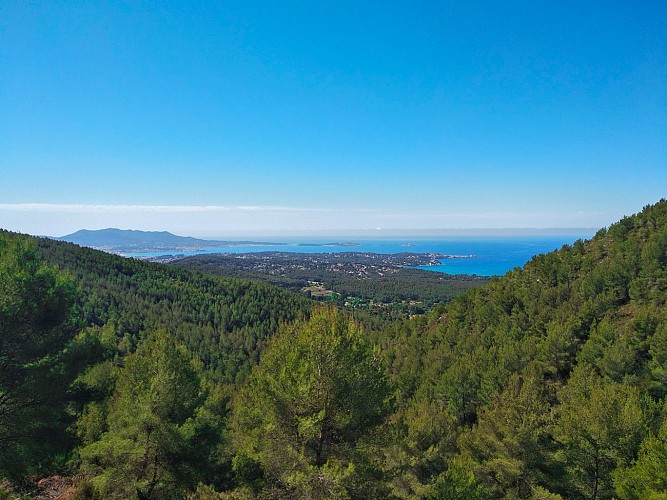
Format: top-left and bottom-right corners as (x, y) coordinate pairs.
(0, 204), (614, 238)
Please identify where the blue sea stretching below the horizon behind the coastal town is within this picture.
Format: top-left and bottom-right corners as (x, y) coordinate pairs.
(127, 231), (593, 276)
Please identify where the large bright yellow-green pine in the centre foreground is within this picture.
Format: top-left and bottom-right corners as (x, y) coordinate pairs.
(234, 309), (390, 498)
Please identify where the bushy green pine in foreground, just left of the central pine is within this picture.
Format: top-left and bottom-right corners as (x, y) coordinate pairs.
(80, 332), (201, 499)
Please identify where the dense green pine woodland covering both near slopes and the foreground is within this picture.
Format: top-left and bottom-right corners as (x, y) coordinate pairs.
(0, 200), (667, 500)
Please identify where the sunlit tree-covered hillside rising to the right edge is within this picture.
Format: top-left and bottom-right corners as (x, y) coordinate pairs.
(376, 200), (667, 498)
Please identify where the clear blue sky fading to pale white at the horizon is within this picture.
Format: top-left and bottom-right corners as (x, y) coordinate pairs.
(0, 1), (667, 235)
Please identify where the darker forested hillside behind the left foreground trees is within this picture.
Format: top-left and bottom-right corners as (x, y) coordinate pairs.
(37, 232), (310, 381)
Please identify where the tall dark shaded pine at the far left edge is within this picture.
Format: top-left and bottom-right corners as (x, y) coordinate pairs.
(0, 233), (75, 476)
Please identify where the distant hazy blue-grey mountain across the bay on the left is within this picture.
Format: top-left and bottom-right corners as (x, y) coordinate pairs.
(54, 228), (276, 253)
